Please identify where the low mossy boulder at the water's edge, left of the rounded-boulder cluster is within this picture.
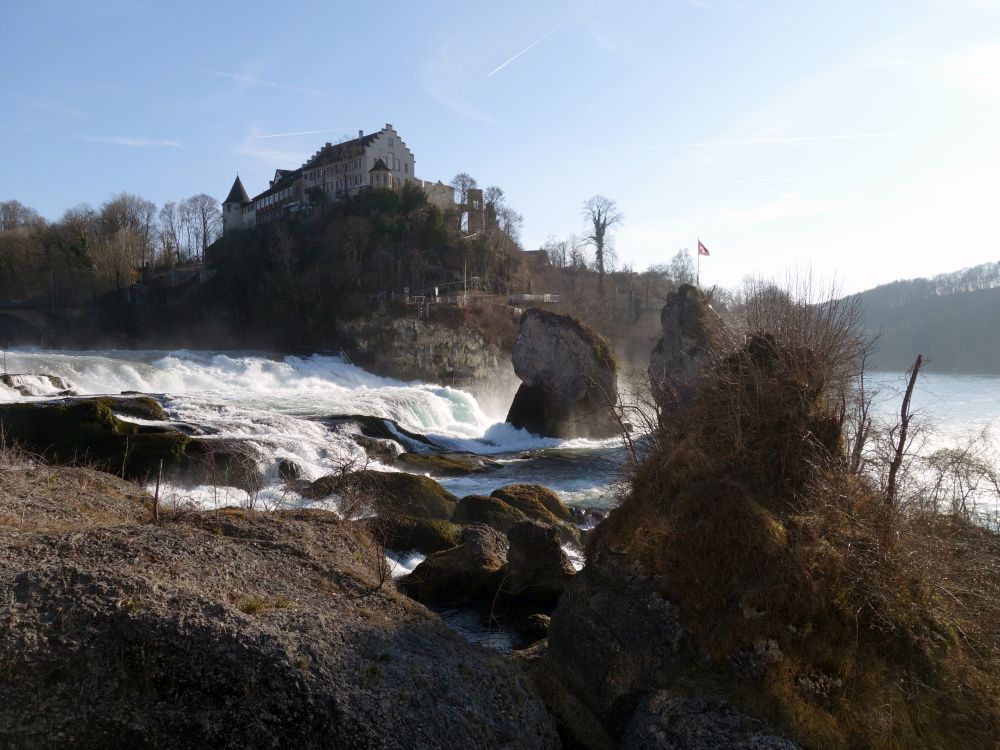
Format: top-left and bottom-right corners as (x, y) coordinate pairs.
(303, 469), (458, 521)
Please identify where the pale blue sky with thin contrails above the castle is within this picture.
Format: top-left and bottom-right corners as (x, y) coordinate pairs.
(0, 0), (1000, 290)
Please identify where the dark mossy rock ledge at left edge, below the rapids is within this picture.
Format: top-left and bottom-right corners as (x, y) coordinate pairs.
(0, 396), (263, 491)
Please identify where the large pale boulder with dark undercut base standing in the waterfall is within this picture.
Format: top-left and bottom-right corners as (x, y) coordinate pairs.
(507, 308), (620, 438)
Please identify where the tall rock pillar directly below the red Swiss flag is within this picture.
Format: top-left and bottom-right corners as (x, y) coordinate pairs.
(649, 284), (724, 420)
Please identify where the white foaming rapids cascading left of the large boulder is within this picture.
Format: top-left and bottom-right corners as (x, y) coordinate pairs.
(0, 351), (616, 507)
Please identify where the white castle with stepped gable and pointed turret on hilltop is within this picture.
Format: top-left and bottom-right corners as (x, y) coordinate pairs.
(222, 123), (455, 233)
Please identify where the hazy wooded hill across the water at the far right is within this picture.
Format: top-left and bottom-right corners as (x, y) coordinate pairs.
(856, 263), (1000, 373)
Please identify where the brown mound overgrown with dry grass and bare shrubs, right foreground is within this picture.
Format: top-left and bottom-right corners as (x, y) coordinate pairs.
(593, 276), (1000, 748)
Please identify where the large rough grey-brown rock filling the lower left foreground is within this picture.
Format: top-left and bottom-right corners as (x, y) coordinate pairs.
(0, 470), (559, 750)
